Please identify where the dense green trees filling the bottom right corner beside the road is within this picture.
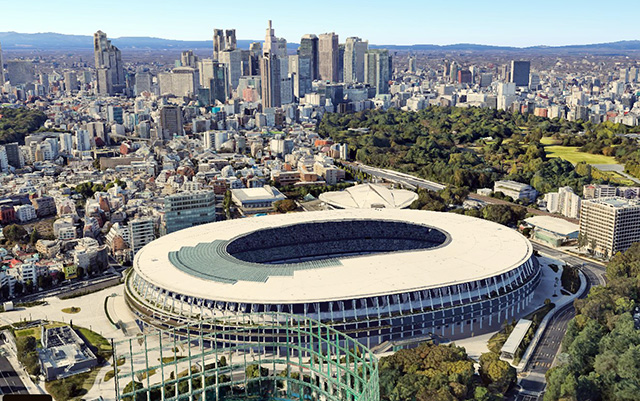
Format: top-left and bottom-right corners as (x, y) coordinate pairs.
(544, 243), (640, 401)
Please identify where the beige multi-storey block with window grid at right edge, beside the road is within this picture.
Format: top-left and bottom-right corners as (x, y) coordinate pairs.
(580, 197), (640, 257)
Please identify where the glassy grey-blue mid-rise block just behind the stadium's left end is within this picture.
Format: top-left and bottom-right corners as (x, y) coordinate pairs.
(163, 191), (216, 234)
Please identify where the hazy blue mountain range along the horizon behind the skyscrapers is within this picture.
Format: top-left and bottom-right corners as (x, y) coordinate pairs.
(0, 32), (640, 54)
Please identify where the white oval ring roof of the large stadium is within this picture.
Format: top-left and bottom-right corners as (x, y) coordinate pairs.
(134, 209), (533, 303)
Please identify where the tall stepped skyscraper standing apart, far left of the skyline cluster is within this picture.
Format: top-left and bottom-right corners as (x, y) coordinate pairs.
(93, 31), (125, 95)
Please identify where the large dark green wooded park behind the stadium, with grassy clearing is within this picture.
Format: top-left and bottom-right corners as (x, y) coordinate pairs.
(318, 106), (640, 193)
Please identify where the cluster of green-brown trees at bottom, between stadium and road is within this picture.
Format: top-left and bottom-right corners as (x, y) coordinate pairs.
(379, 343), (516, 401)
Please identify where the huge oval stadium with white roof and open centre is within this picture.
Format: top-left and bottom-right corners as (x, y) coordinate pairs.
(125, 209), (540, 347)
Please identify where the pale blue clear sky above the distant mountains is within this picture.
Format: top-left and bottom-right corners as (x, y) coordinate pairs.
(0, 0), (640, 47)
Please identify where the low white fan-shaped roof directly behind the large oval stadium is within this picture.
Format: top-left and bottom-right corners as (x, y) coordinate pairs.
(320, 184), (418, 209)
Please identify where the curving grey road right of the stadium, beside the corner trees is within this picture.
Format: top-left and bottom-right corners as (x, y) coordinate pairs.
(516, 243), (605, 401)
